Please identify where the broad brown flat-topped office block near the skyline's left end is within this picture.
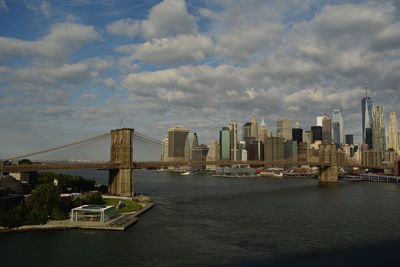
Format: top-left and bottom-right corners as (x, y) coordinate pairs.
(168, 127), (189, 161)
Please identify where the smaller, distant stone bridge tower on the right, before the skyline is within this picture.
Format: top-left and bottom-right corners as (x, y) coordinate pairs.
(319, 144), (338, 183)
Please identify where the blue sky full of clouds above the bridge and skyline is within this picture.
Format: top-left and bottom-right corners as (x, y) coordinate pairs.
(0, 0), (400, 158)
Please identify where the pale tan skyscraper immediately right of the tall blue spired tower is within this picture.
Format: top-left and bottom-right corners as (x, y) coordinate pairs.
(372, 106), (386, 153)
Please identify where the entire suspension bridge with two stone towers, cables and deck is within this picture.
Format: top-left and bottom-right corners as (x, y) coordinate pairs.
(0, 128), (385, 197)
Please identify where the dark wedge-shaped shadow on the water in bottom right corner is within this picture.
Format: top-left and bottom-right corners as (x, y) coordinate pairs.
(230, 239), (400, 267)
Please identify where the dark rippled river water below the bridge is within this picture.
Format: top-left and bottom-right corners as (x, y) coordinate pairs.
(0, 171), (400, 266)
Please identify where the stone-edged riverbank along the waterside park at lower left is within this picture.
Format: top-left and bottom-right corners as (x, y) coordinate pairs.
(0, 202), (154, 233)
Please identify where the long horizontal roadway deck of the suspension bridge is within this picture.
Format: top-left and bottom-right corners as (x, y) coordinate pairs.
(0, 160), (388, 172)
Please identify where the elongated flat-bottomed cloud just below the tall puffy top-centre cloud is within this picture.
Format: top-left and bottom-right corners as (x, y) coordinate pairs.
(116, 35), (213, 64)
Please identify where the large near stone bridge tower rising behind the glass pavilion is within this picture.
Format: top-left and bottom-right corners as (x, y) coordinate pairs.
(108, 128), (134, 197)
